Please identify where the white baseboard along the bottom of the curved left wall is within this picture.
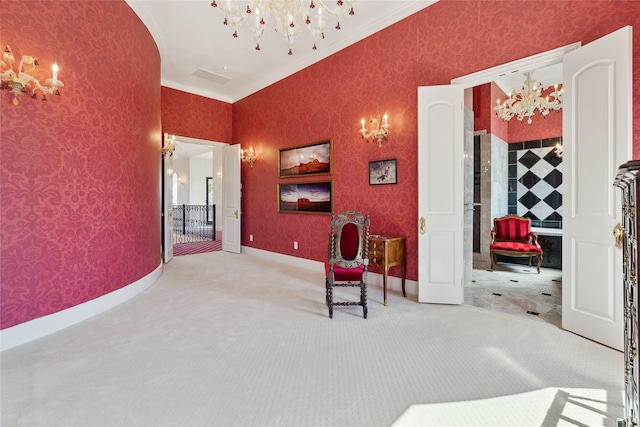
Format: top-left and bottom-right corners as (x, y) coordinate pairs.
(0, 262), (163, 352)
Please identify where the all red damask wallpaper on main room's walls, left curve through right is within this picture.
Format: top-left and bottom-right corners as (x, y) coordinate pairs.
(5, 0), (640, 328)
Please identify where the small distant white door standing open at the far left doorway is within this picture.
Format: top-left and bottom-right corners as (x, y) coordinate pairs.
(222, 144), (242, 254)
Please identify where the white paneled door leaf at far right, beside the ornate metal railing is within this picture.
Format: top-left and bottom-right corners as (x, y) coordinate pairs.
(562, 27), (632, 350)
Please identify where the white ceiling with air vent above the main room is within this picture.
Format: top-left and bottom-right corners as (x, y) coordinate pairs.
(126, 0), (437, 103)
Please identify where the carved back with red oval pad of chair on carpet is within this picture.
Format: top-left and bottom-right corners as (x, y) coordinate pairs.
(329, 210), (369, 268)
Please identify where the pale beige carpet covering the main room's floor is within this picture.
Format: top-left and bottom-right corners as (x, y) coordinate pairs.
(0, 252), (623, 427)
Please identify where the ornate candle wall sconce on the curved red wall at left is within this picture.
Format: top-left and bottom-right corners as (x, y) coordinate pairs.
(0, 45), (64, 105)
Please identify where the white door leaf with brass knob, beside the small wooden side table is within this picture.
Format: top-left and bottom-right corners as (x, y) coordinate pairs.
(418, 85), (464, 304)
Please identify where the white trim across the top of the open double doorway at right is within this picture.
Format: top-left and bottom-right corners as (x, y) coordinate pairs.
(451, 42), (582, 88)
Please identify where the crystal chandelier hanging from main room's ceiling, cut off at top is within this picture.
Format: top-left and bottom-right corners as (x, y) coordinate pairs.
(211, 0), (355, 55)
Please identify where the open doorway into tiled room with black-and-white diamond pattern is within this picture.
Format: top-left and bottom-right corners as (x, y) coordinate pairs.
(464, 70), (562, 327)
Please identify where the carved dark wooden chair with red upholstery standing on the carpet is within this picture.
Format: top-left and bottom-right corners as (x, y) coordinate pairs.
(325, 210), (369, 319)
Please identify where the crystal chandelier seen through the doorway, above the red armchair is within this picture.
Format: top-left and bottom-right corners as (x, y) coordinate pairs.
(493, 71), (563, 124)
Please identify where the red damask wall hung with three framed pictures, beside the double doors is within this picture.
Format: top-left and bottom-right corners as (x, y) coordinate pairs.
(233, 0), (640, 280)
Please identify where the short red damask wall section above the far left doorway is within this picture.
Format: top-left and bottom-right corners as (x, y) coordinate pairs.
(162, 86), (231, 142)
